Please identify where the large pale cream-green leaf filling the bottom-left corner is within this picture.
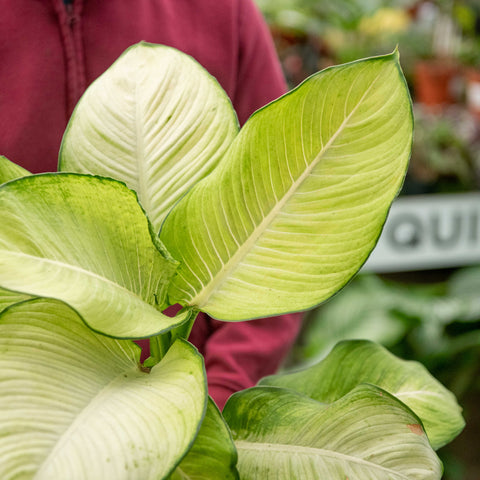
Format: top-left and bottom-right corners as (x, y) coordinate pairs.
(0, 299), (207, 480)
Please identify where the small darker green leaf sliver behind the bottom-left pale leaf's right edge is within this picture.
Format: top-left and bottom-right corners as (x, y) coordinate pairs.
(169, 398), (238, 480)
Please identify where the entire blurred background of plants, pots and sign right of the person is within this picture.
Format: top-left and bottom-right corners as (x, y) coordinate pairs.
(256, 0), (480, 480)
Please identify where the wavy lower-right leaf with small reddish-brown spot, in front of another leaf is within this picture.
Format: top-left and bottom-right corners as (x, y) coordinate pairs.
(223, 385), (442, 480)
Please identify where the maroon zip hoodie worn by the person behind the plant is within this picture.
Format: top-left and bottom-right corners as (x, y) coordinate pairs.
(0, 0), (300, 408)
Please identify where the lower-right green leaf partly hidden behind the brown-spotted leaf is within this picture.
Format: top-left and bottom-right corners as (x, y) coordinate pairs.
(260, 340), (465, 449)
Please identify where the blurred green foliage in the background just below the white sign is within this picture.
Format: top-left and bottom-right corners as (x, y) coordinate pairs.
(292, 267), (480, 374)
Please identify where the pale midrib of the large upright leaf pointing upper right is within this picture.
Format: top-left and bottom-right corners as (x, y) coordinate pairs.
(189, 73), (380, 309)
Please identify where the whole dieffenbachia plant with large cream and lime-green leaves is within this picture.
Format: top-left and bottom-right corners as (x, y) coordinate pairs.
(0, 43), (463, 480)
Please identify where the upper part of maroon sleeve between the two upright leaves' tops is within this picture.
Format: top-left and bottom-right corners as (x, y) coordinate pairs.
(232, 0), (287, 125)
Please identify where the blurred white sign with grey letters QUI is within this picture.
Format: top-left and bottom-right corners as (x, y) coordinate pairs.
(363, 193), (480, 272)
